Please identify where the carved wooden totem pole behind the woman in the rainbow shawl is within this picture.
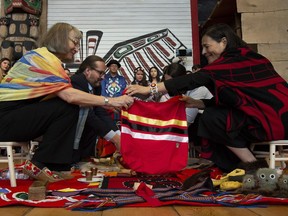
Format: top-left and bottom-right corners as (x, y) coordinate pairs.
(0, 0), (42, 62)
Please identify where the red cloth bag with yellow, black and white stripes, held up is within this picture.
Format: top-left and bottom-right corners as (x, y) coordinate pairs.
(121, 97), (188, 175)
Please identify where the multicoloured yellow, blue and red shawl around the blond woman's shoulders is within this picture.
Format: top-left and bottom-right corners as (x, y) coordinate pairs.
(0, 47), (71, 101)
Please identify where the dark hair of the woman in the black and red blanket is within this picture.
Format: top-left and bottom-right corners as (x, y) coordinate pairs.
(202, 23), (247, 50)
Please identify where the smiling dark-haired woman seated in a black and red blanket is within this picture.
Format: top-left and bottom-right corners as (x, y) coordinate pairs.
(126, 24), (288, 171)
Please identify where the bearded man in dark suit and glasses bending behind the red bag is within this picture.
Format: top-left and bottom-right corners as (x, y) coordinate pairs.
(71, 55), (120, 162)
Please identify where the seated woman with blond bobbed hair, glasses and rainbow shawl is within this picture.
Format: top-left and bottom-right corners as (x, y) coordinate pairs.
(0, 23), (133, 182)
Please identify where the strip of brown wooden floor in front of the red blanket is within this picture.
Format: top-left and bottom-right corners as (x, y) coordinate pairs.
(0, 163), (288, 216)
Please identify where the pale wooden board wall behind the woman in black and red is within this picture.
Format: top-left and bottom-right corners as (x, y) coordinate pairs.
(237, 0), (288, 81)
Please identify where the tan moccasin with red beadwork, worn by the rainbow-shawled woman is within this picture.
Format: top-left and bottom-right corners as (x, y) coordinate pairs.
(23, 160), (63, 182)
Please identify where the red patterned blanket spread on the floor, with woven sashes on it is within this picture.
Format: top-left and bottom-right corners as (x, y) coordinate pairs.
(0, 165), (288, 211)
